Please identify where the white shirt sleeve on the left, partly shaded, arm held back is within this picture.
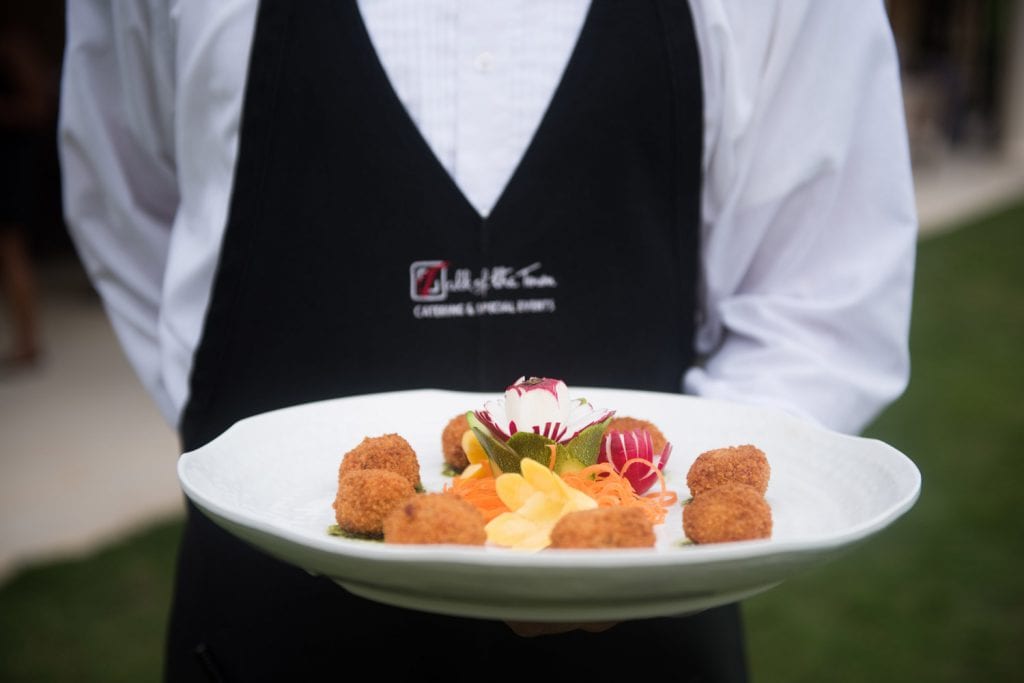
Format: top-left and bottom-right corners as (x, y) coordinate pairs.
(58, 0), (178, 422)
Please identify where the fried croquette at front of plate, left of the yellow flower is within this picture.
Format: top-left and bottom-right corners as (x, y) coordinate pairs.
(384, 494), (487, 546)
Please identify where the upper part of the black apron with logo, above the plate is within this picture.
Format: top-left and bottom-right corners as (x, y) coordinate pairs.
(178, 2), (702, 445)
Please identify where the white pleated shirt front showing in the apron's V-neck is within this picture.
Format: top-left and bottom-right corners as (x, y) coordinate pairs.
(355, 0), (591, 218)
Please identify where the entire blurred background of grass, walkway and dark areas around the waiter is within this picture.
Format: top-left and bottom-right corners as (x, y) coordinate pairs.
(0, 0), (1024, 681)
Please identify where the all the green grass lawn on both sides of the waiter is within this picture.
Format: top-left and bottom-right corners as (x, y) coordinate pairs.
(0, 198), (1024, 683)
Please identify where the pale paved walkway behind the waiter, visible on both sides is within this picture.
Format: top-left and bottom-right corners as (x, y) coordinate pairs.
(0, 160), (1024, 582)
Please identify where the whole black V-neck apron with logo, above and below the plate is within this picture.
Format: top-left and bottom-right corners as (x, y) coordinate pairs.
(168, 0), (743, 681)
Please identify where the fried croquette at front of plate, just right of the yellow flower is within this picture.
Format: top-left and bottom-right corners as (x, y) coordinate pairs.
(549, 507), (654, 548)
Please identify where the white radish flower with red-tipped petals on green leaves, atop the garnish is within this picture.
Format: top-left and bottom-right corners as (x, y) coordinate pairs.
(466, 377), (614, 473)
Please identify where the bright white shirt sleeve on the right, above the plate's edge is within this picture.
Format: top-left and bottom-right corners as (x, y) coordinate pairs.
(684, 0), (918, 432)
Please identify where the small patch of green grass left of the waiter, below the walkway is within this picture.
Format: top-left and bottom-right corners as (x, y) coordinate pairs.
(0, 520), (181, 683)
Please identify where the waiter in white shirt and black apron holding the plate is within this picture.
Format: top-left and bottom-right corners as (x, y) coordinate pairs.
(60, 0), (915, 681)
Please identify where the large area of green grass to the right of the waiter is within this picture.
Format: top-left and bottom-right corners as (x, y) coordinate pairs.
(745, 198), (1024, 683)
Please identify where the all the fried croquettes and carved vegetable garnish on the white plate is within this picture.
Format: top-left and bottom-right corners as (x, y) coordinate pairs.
(330, 377), (772, 552)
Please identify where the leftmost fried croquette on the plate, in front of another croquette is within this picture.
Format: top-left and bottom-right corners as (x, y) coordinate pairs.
(334, 469), (417, 539)
